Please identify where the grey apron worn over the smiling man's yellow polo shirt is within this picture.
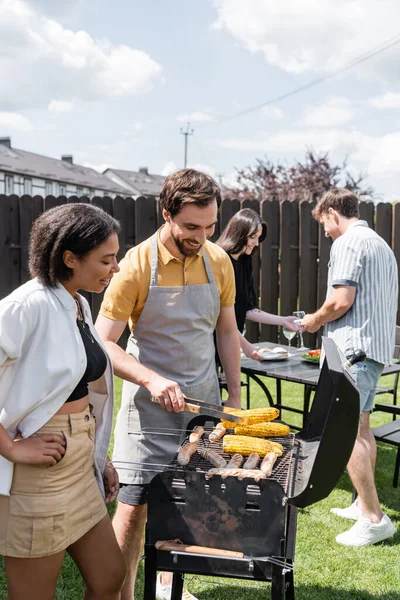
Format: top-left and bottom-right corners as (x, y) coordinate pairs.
(113, 233), (221, 484)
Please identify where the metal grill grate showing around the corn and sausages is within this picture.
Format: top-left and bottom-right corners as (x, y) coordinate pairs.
(165, 427), (298, 495)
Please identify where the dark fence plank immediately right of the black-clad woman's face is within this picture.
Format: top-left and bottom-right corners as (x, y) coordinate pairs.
(260, 200), (280, 342)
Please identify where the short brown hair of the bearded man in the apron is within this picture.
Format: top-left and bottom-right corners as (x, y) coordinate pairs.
(160, 169), (221, 217)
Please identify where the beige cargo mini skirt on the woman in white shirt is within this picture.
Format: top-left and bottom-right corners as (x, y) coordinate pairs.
(0, 408), (107, 558)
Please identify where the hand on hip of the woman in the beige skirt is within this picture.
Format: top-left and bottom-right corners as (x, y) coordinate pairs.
(5, 433), (65, 467)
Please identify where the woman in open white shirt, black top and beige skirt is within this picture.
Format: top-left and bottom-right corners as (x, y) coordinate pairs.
(0, 204), (125, 600)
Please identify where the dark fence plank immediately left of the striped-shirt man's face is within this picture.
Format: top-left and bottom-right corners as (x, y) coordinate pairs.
(298, 201), (318, 348)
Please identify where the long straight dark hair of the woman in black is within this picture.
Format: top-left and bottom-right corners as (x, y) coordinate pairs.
(216, 208), (267, 254)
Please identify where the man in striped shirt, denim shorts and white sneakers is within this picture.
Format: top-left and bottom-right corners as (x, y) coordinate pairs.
(302, 189), (398, 546)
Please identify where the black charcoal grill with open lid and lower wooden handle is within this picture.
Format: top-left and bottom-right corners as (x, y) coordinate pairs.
(144, 338), (359, 600)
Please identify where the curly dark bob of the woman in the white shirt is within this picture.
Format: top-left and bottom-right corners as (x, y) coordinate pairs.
(29, 203), (120, 287)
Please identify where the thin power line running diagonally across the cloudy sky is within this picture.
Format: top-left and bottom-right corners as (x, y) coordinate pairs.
(203, 35), (400, 127)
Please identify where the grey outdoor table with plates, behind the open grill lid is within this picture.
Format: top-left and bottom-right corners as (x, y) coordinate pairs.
(240, 342), (400, 429)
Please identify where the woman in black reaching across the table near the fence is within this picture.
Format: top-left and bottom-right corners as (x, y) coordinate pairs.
(217, 208), (299, 360)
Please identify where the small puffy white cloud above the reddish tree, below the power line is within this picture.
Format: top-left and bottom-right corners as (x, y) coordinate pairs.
(300, 98), (356, 127)
